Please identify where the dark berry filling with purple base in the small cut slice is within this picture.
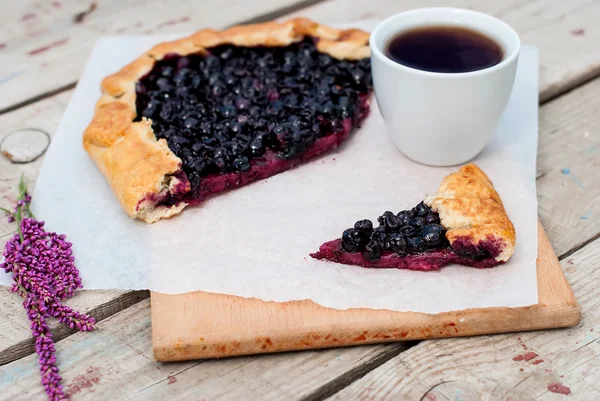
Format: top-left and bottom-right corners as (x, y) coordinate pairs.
(311, 202), (502, 271)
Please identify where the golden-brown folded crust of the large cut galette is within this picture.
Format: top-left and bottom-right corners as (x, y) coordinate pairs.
(83, 18), (370, 223)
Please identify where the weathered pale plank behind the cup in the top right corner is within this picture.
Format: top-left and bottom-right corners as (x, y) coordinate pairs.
(295, 0), (600, 100)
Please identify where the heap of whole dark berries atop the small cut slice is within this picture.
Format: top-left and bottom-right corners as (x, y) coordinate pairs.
(341, 202), (449, 261)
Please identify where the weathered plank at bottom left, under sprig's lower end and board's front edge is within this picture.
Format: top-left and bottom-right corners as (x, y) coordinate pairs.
(0, 300), (404, 401)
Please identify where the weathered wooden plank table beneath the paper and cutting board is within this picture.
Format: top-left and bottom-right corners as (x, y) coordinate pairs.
(0, 0), (600, 401)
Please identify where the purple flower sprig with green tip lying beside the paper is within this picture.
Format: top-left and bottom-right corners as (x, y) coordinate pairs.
(0, 177), (95, 401)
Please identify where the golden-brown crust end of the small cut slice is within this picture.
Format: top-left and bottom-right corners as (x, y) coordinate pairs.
(425, 164), (516, 262)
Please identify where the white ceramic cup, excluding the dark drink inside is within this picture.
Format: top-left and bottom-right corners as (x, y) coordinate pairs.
(369, 8), (521, 166)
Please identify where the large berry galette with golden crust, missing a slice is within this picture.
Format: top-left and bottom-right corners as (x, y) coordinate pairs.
(83, 19), (372, 223)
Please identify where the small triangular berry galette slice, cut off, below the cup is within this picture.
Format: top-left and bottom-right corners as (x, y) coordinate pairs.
(311, 164), (515, 270)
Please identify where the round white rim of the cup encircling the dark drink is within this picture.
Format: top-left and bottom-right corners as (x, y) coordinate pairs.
(369, 7), (521, 79)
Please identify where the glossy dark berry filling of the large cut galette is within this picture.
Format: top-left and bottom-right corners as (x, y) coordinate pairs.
(136, 38), (372, 199)
